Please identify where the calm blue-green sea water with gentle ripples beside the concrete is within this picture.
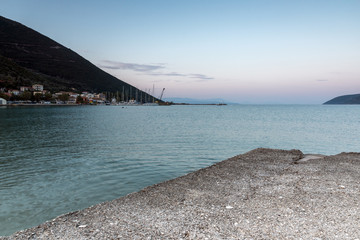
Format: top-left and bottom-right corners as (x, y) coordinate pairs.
(0, 105), (360, 235)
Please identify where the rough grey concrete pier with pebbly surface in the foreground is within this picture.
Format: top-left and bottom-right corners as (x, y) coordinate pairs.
(0, 149), (360, 239)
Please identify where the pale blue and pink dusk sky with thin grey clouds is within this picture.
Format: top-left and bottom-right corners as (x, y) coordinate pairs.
(0, 0), (360, 104)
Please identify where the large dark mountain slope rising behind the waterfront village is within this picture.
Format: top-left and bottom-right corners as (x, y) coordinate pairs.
(0, 16), (153, 100)
